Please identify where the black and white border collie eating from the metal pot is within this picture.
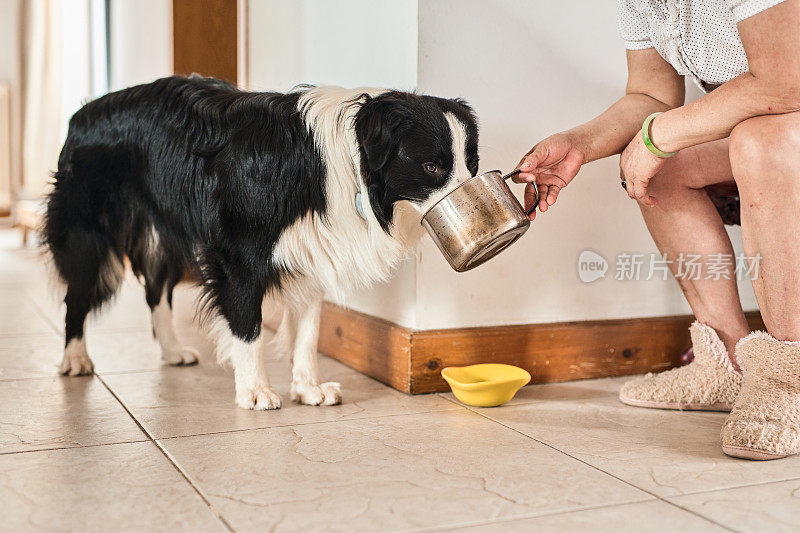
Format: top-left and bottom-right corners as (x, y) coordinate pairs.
(43, 76), (478, 409)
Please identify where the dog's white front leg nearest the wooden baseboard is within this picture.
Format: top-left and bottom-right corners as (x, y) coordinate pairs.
(284, 297), (342, 405)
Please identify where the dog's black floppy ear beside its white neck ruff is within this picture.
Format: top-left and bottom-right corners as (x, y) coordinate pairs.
(355, 93), (410, 172)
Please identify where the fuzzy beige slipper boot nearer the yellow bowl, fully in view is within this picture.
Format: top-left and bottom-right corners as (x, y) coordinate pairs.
(619, 322), (742, 411)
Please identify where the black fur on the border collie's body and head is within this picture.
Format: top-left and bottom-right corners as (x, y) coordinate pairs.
(43, 72), (477, 352)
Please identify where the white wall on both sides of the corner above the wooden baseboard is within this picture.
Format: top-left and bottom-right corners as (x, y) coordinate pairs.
(249, 0), (755, 329)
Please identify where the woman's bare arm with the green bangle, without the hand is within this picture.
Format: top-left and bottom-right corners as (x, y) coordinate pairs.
(650, 0), (800, 152)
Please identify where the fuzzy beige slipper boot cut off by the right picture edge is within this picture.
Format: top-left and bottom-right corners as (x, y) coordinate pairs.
(722, 331), (800, 460)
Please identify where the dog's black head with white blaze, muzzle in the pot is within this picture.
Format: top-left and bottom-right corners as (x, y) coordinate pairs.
(355, 91), (478, 231)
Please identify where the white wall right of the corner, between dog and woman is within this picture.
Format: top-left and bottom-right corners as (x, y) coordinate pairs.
(415, 0), (752, 328)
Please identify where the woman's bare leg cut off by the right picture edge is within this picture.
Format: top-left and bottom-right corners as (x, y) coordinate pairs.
(730, 112), (800, 341)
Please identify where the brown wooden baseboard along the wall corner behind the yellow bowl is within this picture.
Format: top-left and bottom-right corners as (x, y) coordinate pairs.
(265, 302), (764, 394)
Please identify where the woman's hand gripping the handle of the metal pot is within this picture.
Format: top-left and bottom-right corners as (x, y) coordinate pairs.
(513, 133), (585, 220)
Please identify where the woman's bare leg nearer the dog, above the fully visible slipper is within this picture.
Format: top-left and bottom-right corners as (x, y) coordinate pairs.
(641, 139), (750, 365)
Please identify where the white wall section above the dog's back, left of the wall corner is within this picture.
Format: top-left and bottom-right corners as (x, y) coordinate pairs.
(248, 0), (417, 91)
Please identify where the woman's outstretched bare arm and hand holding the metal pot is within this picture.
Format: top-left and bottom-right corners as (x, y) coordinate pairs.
(514, 48), (684, 216)
